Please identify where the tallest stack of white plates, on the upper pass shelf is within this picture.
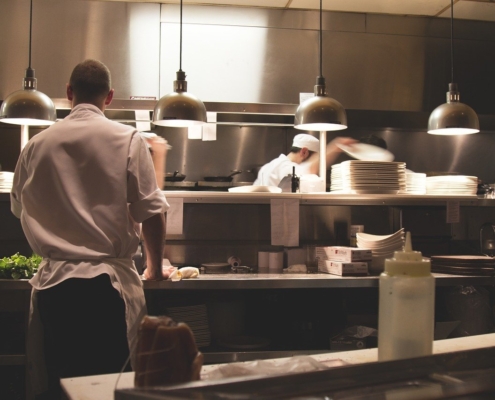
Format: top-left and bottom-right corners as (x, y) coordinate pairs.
(330, 160), (406, 194)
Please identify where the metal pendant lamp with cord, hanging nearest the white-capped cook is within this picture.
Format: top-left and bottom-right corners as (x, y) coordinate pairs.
(294, 0), (347, 132)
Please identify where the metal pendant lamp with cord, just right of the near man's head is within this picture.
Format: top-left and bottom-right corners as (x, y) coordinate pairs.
(153, 0), (206, 127)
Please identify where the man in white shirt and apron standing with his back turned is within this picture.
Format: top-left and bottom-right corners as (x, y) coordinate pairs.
(11, 60), (169, 399)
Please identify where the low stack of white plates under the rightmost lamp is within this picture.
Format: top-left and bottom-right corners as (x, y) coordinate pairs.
(426, 175), (478, 196)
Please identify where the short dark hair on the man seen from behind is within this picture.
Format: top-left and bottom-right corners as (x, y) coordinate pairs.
(69, 59), (111, 103)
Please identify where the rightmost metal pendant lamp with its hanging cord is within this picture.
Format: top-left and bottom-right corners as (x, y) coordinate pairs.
(428, 0), (480, 135)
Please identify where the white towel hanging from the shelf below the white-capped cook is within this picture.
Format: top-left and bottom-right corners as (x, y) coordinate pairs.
(270, 199), (299, 247)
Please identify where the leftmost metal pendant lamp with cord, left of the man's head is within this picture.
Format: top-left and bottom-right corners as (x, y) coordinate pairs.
(0, 0), (57, 126)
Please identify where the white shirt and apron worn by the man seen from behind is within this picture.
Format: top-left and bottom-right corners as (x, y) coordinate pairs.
(11, 104), (169, 390)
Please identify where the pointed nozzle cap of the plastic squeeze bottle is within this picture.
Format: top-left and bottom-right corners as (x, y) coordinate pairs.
(384, 232), (431, 277)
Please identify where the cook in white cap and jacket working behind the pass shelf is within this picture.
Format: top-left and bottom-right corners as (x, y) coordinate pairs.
(253, 133), (356, 186)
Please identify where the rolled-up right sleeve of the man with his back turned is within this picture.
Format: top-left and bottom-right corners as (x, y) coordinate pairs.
(127, 134), (170, 223)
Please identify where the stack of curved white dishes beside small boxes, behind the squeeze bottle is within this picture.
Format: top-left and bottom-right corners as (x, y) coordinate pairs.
(356, 228), (405, 272)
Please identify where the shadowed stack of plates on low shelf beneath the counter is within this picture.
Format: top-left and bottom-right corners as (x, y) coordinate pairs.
(167, 304), (211, 347)
